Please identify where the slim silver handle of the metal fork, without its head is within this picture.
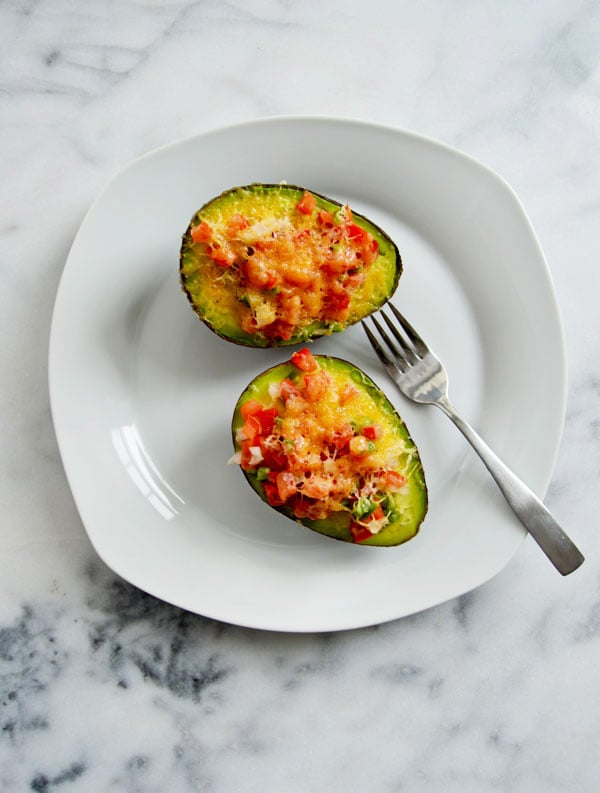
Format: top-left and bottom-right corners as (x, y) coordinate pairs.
(434, 399), (584, 575)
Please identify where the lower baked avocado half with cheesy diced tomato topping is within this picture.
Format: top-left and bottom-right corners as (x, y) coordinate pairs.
(232, 348), (427, 546)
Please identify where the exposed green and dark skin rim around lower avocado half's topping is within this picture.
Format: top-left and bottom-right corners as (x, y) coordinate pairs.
(231, 355), (428, 547)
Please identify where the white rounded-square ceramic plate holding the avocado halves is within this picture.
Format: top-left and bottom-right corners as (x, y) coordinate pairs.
(49, 118), (566, 631)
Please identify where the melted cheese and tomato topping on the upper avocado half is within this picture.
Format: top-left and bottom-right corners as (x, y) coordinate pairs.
(184, 192), (379, 342)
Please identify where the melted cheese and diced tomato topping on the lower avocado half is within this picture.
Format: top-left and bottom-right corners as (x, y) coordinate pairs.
(237, 349), (412, 541)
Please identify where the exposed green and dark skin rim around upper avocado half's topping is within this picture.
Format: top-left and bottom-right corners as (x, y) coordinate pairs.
(179, 182), (403, 349)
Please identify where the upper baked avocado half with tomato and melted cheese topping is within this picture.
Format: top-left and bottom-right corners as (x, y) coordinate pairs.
(180, 184), (402, 347)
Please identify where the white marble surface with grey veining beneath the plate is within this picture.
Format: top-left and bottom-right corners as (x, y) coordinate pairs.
(0, 0), (600, 793)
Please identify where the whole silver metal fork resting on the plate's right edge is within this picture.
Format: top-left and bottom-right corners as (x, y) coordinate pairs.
(362, 303), (584, 575)
